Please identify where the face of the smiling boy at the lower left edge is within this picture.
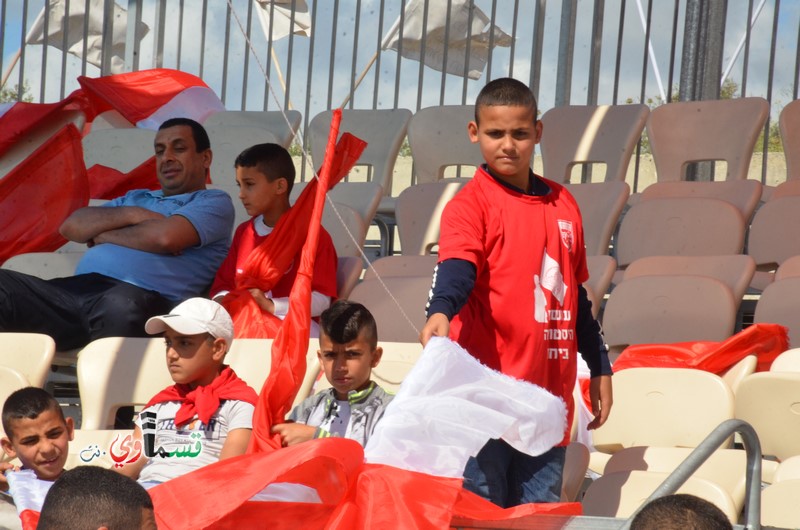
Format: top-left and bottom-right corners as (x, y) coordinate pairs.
(2, 409), (73, 480)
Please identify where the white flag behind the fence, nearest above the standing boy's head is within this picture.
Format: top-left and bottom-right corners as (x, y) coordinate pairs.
(383, 0), (512, 79)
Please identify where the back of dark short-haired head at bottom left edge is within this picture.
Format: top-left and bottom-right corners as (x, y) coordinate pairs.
(37, 466), (153, 530)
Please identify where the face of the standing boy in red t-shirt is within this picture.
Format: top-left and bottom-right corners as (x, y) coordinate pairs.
(467, 105), (542, 189)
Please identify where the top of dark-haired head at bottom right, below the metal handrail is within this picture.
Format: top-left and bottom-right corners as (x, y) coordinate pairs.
(631, 493), (733, 530)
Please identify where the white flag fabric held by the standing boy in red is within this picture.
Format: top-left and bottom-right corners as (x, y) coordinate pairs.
(364, 337), (567, 477)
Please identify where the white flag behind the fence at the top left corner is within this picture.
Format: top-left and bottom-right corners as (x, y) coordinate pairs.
(25, 0), (150, 74)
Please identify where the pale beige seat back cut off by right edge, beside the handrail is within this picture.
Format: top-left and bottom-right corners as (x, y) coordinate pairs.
(736, 372), (800, 460)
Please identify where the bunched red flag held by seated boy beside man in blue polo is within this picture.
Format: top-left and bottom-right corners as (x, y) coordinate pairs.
(222, 130), (366, 336)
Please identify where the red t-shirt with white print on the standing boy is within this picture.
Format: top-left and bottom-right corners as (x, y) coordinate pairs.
(439, 168), (588, 444)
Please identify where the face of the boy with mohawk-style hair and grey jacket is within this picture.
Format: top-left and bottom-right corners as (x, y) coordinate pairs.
(317, 330), (383, 400)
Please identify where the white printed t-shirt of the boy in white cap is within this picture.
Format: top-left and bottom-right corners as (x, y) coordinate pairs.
(136, 400), (255, 483)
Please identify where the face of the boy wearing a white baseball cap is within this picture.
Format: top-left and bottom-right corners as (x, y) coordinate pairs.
(164, 328), (226, 388)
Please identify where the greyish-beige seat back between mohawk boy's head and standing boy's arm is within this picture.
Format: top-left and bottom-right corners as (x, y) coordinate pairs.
(350, 276), (431, 342)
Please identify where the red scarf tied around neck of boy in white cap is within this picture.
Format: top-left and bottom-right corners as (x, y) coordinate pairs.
(146, 366), (258, 425)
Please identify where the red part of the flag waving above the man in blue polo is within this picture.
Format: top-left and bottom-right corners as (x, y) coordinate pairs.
(78, 68), (213, 124)
